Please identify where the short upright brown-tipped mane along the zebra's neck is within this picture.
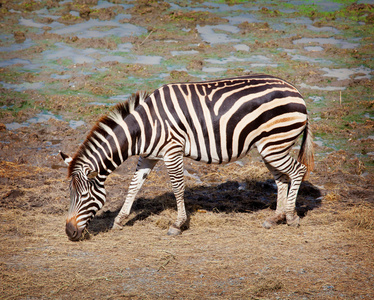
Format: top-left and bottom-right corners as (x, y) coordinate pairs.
(68, 91), (148, 177)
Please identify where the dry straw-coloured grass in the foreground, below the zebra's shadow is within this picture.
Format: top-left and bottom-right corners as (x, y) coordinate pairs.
(0, 200), (373, 299)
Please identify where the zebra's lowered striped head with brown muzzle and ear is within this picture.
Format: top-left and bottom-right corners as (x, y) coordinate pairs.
(61, 152), (106, 241)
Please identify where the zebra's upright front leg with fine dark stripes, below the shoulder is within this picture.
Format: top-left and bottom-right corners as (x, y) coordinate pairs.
(164, 149), (187, 235)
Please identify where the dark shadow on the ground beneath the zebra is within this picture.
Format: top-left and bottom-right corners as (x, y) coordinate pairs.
(88, 179), (322, 235)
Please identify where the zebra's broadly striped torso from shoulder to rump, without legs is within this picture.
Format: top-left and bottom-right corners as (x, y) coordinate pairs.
(145, 75), (307, 163)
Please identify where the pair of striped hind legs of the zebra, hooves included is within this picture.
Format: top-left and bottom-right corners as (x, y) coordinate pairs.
(263, 155), (306, 228)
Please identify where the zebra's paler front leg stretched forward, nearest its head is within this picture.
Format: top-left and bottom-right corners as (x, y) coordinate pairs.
(112, 157), (157, 229)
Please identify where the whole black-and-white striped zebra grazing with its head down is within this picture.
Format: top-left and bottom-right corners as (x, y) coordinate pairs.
(61, 75), (313, 240)
